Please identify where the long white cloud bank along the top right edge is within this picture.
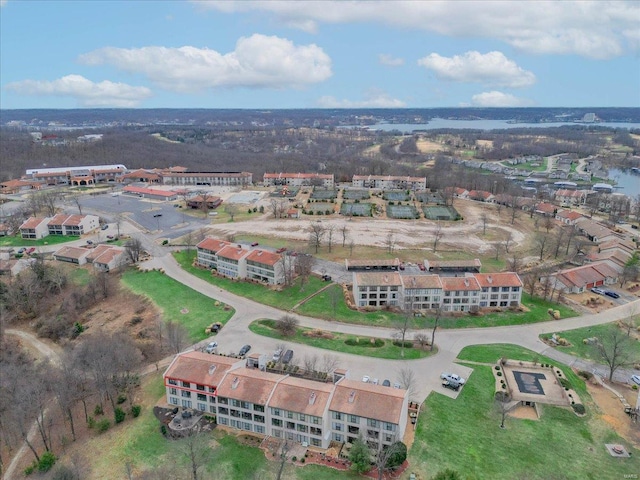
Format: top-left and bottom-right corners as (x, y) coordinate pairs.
(193, 0), (640, 59)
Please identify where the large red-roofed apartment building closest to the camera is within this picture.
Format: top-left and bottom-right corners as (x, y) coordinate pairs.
(164, 351), (408, 449)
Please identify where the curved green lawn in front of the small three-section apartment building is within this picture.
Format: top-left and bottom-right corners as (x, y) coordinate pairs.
(173, 250), (326, 310)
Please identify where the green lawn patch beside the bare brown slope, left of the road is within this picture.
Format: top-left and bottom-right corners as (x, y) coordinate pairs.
(122, 268), (234, 342)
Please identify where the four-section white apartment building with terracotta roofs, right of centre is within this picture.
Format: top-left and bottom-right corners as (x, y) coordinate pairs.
(353, 272), (523, 312)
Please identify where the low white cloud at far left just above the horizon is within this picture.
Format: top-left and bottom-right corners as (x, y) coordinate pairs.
(5, 75), (152, 107)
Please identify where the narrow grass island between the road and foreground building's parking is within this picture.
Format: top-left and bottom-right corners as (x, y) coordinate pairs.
(249, 320), (435, 360)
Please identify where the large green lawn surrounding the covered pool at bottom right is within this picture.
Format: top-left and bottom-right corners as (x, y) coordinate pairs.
(409, 345), (640, 480)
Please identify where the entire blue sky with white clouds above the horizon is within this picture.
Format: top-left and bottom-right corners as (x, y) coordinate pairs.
(0, 0), (640, 108)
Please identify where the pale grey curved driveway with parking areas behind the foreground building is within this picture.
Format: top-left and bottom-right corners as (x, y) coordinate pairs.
(141, 249), (640, 402)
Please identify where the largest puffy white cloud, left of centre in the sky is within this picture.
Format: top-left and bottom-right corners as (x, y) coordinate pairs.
(79, 34), (332, 92)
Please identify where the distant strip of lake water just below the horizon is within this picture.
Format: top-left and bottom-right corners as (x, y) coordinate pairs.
(358, 118), (640, 133)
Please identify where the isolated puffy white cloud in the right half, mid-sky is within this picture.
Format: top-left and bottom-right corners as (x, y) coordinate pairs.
(418, 51), (536, 88)
